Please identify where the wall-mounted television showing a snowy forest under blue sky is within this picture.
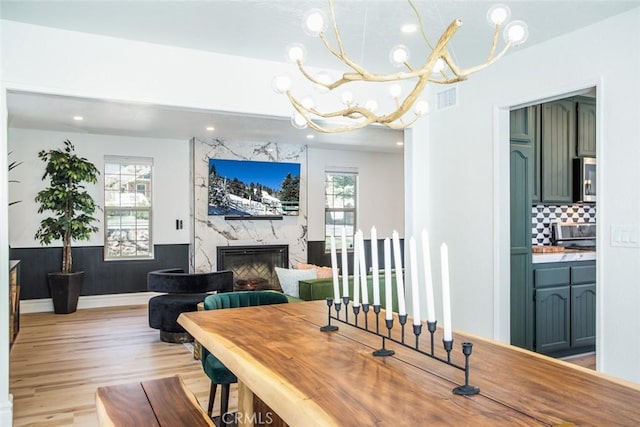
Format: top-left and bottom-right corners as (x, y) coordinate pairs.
(208, 159), (300, 218)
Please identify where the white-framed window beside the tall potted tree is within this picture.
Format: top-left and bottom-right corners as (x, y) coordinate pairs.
(104, 157), (153, 260)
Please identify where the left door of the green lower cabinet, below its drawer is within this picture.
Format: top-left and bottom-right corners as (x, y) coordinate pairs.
(535, 285), (571, 353)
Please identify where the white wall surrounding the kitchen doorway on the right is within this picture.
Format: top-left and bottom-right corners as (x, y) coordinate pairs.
(406, 8), (640, 382)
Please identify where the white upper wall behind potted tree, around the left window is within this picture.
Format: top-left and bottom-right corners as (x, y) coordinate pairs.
(8, 128), (191, 248)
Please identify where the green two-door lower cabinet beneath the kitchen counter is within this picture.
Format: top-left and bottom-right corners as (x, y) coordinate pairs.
(533, 261), (596, 355)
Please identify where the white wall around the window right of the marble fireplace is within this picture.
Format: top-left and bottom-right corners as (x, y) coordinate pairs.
(307, 147), (404, 241)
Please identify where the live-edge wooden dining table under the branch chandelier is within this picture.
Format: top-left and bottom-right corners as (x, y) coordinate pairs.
(178, 301), (640, 427)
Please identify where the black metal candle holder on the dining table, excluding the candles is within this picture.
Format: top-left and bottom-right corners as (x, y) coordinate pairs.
(320, 296), (480, 396)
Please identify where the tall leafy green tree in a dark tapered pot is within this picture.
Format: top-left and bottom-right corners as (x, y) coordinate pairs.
(35, 140), (100, 314)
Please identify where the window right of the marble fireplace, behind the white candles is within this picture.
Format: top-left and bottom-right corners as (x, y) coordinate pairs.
(324, 172), (358, 251)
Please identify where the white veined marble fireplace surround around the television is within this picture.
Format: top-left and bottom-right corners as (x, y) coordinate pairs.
(191, 138), (308, 276)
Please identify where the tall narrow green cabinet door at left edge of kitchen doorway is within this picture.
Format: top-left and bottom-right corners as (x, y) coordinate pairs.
(510, 135), (533, 349)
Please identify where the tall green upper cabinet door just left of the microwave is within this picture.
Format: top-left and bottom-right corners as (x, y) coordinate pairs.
(540, 99), (576, 204)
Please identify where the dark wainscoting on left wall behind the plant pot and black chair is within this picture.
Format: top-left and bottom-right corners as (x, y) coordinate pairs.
(10, 244), (189, 300)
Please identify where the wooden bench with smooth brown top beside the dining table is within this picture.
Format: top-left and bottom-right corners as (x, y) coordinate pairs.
(96, 375), (215, 427)
